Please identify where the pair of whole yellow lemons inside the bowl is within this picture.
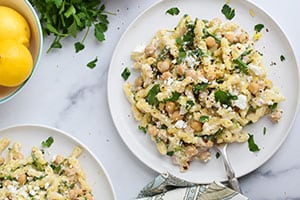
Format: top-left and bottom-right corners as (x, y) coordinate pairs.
(0, 6), (33, 87)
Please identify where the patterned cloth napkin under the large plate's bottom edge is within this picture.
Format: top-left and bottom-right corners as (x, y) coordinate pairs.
(137, 173), (249, 200)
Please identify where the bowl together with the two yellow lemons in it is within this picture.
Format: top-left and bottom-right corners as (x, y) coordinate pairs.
(0, 0), (43, 104)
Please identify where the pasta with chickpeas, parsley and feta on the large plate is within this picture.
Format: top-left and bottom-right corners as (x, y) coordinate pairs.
(124, 15), (284, 171)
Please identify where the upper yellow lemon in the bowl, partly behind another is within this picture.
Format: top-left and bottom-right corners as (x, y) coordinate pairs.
(0, 6), (30, 47)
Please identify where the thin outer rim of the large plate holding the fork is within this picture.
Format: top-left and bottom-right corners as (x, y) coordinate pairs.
(106, 0), (300, 183)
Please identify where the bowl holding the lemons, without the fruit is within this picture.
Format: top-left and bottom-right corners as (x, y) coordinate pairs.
(0, 0), (43, 104)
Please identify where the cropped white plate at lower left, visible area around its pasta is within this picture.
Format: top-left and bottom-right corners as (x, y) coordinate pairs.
(0, 125), (115, 200)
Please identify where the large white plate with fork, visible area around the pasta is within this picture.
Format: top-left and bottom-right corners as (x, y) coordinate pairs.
(108, 0), (299, 183)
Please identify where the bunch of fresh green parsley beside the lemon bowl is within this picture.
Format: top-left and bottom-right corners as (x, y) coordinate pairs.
(29, 0), (109, 53)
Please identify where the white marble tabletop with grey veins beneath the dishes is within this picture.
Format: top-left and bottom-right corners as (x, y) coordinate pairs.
(0, 0), (300, 200)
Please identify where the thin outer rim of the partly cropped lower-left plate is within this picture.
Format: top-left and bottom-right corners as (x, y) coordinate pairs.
(0, 123), (116, 199)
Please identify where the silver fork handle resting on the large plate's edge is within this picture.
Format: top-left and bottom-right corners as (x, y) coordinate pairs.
(214, 143), (242, 193)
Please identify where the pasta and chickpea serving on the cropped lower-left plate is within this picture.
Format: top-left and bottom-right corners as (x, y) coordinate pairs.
(0, 139), (93, 200)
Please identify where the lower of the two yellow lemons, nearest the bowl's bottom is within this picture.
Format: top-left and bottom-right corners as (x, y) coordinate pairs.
(0, 40), (33, 87)
